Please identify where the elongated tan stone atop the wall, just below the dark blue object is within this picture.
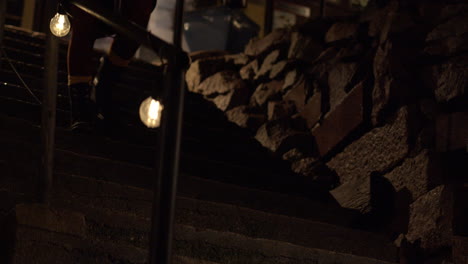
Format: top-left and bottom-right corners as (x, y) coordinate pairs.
(244, 29), (290, 57)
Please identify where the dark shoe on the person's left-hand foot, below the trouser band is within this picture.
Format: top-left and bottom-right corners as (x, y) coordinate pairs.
(69, 83), (96, 132)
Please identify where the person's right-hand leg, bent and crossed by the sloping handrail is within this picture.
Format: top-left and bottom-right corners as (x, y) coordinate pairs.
(95, 0), (156, 120)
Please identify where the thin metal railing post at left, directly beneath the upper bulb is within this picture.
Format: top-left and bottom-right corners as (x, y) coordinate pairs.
(39, 0), (59, 203)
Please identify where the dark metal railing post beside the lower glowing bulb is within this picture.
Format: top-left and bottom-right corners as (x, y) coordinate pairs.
(149, 0), (185, 264)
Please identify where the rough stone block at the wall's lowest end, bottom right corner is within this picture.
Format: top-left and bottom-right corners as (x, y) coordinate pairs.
(406, 185), (453, 250)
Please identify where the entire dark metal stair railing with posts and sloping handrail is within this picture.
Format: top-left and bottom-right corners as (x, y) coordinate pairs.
(0, 0), (188, 264)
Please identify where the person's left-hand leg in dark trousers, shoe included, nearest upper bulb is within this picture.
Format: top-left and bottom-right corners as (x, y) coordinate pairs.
(67, 6), (97, 130)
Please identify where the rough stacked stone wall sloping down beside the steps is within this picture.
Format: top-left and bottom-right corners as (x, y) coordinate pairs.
(186, 1), (468, 262)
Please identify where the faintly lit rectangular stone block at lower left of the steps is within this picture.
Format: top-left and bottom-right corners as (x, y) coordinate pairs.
(16, 204), (86, 237)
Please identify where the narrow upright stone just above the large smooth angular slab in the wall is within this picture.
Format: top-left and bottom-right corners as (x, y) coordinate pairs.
(328, 63), (358, 110)
